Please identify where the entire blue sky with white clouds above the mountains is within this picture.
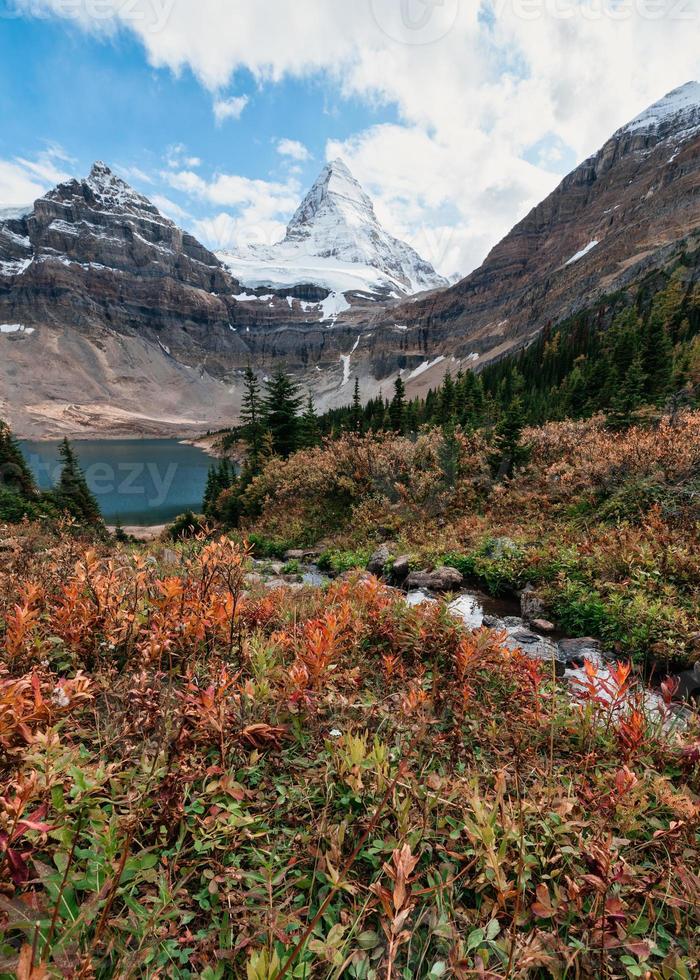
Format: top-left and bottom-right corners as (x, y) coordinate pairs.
(0, 0), (700, 274)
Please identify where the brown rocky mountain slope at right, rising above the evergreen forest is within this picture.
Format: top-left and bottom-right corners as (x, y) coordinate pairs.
(382, 82), (700, 368)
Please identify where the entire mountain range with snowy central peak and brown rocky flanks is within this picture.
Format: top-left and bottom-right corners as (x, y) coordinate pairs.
(0, 82), (700, 435)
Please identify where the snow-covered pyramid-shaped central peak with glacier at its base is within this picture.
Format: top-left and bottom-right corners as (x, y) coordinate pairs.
(218, 160), (447, 297)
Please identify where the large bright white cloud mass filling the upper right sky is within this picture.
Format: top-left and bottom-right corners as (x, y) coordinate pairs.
(13, 0), (700, 272)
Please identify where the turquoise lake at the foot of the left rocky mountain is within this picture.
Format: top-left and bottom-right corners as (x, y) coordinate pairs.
(21, 439), (213, 526)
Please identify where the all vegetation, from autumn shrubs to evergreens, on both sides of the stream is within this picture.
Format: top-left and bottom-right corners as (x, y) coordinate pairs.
(0, 264), (700, 980)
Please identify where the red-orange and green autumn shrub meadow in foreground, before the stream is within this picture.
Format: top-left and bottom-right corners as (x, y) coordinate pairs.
(0, 532), (700, 980)
